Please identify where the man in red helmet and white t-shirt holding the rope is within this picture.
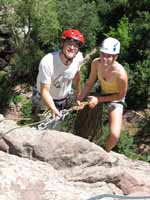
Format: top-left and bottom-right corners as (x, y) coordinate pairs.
(33, 29), (84, 118)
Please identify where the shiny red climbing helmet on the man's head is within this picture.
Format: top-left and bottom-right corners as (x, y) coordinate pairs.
(61, 29), (84, 44)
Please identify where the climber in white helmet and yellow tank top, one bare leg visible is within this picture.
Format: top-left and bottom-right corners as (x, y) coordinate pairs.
(78, 37), (128, 152)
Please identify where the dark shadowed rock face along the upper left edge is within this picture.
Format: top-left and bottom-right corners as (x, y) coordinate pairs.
(0, 5), (14, 70)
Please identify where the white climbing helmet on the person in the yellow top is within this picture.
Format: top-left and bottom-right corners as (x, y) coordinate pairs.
(100, 37), (120, 55)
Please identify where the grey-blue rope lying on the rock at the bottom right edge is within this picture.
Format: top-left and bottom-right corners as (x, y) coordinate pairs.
(87, 194), (150, 200)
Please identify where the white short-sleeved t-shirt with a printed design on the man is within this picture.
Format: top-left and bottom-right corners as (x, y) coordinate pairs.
(37, 51), (84, 99)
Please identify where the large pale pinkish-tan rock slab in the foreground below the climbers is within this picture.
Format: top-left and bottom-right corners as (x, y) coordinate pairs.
(0, 116), (150, 200)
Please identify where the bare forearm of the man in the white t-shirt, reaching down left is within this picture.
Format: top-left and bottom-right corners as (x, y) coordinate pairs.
(40, 83), (60, 116)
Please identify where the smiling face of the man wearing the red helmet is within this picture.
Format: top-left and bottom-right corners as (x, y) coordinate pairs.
(63, 39), (79, 59)
